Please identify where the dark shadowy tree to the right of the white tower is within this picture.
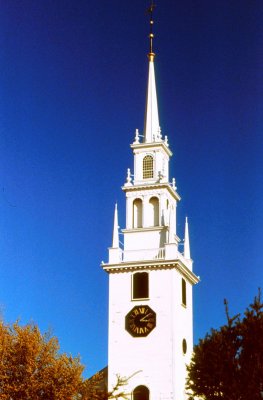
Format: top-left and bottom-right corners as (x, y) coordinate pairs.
(187, 291), (263, 400)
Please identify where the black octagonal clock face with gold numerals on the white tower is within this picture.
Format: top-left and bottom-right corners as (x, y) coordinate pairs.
(125, 305), (156, 337)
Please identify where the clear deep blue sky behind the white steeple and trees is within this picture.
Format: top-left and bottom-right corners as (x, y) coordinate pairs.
(0, 0), (263, 375)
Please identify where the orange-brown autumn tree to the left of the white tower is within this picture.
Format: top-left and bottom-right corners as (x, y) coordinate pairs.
(0, 321), (83, 400)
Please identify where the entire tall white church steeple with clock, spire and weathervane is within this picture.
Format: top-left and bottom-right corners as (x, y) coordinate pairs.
(102, 6), (198, 400)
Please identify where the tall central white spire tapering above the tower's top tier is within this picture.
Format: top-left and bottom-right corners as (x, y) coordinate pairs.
(144, 53), (160, 143)
